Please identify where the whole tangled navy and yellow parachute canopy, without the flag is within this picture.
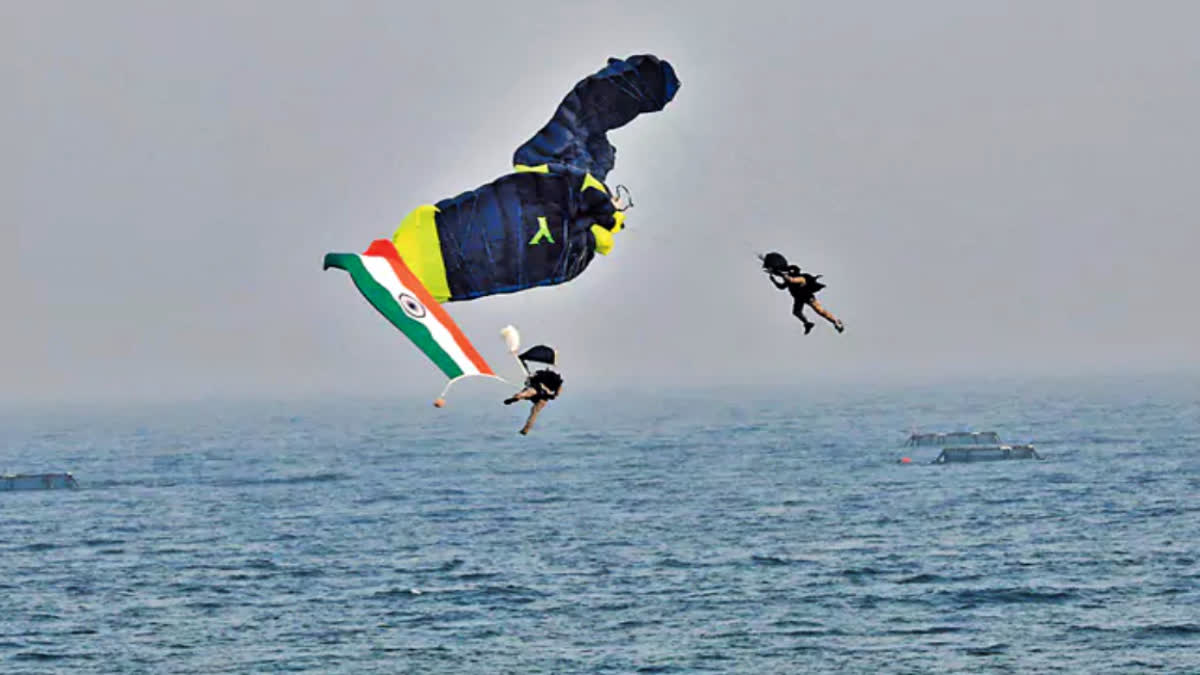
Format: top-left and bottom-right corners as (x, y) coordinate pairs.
(392, 55), (679, 301)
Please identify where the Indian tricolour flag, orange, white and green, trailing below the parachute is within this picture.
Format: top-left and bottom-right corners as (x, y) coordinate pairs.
(325, 239), (496, 388)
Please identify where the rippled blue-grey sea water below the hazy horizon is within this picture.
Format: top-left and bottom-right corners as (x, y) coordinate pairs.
(0, 377), (1200, 674)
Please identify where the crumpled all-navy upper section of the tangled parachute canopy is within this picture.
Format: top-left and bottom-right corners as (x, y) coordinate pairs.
(512, 54), (679, 180)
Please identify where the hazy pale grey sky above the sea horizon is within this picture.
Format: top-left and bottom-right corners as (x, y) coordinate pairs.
(0, 0), (1200, 400)
